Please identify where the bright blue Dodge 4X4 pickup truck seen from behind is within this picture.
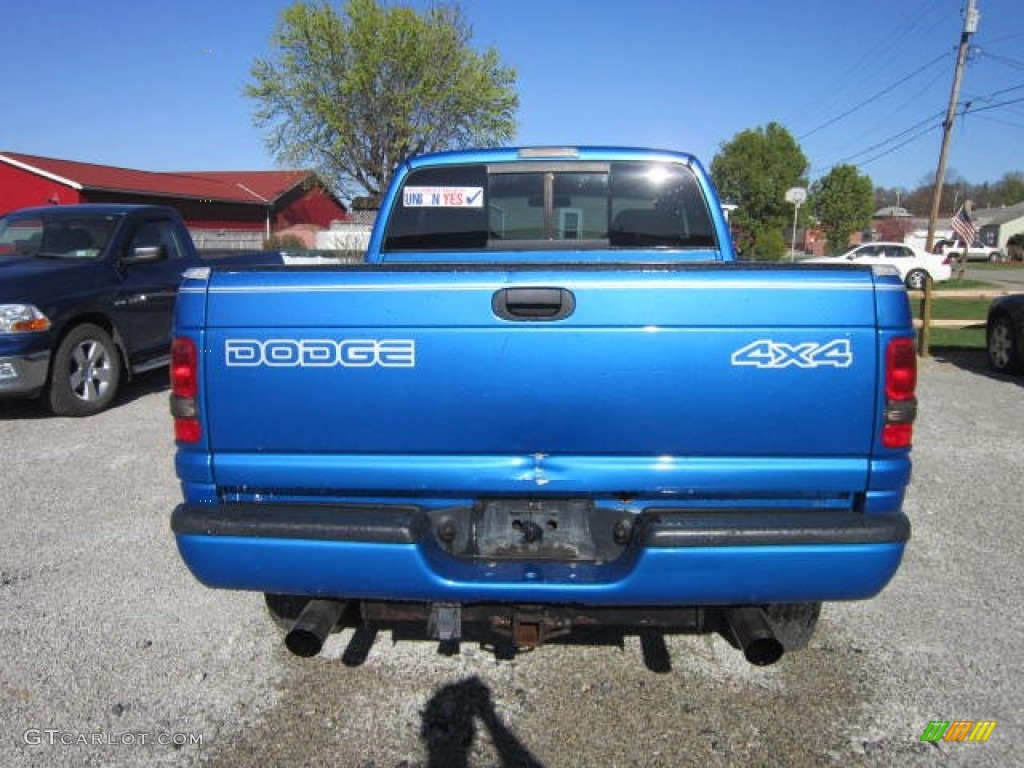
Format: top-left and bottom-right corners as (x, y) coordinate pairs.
(171, 147), (916, 665)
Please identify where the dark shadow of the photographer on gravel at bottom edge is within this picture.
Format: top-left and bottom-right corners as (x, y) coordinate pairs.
(420, 675), (542, 768)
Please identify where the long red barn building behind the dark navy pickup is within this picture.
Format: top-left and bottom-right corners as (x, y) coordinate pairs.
(0, 152), (348, 248)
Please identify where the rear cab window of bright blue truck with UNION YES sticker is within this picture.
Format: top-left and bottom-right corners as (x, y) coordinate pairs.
(383, 162), (718, 252)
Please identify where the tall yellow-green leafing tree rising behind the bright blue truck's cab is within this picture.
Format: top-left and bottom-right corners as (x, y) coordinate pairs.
(245, 0), (519, 196)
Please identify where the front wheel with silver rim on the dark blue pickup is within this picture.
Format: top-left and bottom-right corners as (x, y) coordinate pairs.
(49, 323), (121, 416)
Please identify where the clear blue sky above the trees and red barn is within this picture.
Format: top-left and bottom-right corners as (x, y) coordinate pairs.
(0, 0), (1024, 195)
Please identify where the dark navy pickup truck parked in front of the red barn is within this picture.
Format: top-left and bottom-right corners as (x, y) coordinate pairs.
(0, 205), (281, 416)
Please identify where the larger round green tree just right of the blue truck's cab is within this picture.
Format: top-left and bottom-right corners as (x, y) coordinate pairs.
(711, 123), (807, 259)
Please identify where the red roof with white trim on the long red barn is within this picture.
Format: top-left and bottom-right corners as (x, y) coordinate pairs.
(0, 152), (314, 206)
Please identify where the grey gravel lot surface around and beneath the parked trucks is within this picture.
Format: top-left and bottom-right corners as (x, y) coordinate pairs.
(0, 353), (1024, 768)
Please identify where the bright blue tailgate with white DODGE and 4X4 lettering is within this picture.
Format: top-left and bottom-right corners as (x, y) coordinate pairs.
(201, 265), (880, 495)
